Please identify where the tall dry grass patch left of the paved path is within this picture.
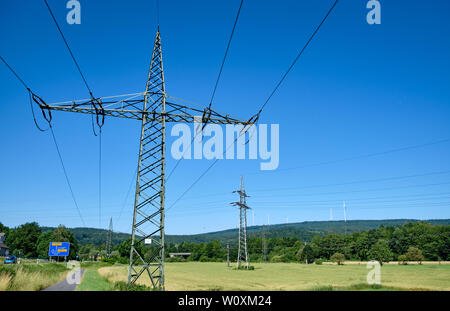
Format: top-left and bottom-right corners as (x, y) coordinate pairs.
(0, 263), (69, 291)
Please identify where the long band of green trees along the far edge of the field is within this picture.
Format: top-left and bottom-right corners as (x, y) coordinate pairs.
(0, 222), (450, 263)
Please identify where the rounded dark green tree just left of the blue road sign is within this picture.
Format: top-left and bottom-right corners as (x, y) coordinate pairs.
(6, 222), (41, 257)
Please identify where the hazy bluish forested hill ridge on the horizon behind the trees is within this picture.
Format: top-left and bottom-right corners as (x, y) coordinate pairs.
(43, 219), (450, 245)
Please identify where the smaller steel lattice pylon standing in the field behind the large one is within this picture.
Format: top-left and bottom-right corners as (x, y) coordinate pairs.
(231, 176), (250, 269)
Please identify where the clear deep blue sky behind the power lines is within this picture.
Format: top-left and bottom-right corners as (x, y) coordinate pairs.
(0, 0), (450, 234)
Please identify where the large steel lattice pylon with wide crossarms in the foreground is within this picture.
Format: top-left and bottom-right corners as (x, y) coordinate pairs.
(37, 29), (254, 290)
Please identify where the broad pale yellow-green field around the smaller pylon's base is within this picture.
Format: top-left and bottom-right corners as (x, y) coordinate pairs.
(98, 262), (450, 291)
